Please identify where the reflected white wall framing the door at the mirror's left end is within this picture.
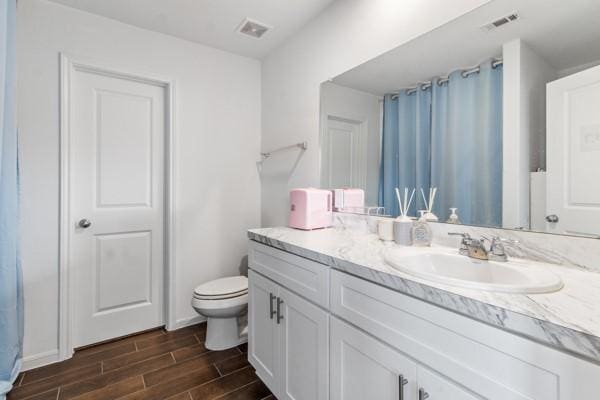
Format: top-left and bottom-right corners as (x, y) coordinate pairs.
(320, 82), (383, 206)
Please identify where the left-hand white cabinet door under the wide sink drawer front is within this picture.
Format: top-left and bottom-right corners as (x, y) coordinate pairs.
(331, 317), (418, 400)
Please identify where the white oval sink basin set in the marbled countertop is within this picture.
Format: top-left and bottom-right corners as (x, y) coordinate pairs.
(385, 247), (563, 293)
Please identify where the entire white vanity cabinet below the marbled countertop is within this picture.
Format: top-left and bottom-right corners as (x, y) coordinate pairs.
(248, 242), (600, 400)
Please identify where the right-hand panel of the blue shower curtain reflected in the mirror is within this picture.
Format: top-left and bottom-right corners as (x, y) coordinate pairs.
(431, 62), (502, 226)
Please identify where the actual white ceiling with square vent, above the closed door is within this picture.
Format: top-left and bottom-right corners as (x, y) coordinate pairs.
(51, 0), (334, 59)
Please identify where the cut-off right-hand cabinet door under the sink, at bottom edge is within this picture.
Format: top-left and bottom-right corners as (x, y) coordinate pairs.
(417, 365), (484, 400)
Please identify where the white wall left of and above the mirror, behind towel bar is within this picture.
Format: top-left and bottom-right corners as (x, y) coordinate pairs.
(261, 0), (488, 226)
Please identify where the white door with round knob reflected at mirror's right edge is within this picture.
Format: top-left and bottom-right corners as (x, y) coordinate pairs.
(547, 67), (600, 235)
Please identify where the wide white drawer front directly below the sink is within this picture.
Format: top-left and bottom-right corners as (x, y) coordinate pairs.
(331, 271), (559, 400)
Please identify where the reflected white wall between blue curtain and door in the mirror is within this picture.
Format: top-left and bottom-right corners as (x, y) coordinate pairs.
(502, 39), (558, 229)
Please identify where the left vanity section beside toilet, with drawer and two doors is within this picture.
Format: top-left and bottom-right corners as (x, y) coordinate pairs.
(248, 244), (329, 400)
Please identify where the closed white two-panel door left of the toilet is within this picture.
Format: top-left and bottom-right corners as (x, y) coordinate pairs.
(66, 63), (167, 347)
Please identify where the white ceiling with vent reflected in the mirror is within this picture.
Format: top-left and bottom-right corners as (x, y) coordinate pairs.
(333, 0), (600, 95)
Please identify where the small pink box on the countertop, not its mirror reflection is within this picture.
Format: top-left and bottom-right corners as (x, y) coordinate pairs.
(289, 188), (333, 230)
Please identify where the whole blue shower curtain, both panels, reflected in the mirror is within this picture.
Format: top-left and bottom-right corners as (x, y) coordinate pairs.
(379, 62), (502, 226)
